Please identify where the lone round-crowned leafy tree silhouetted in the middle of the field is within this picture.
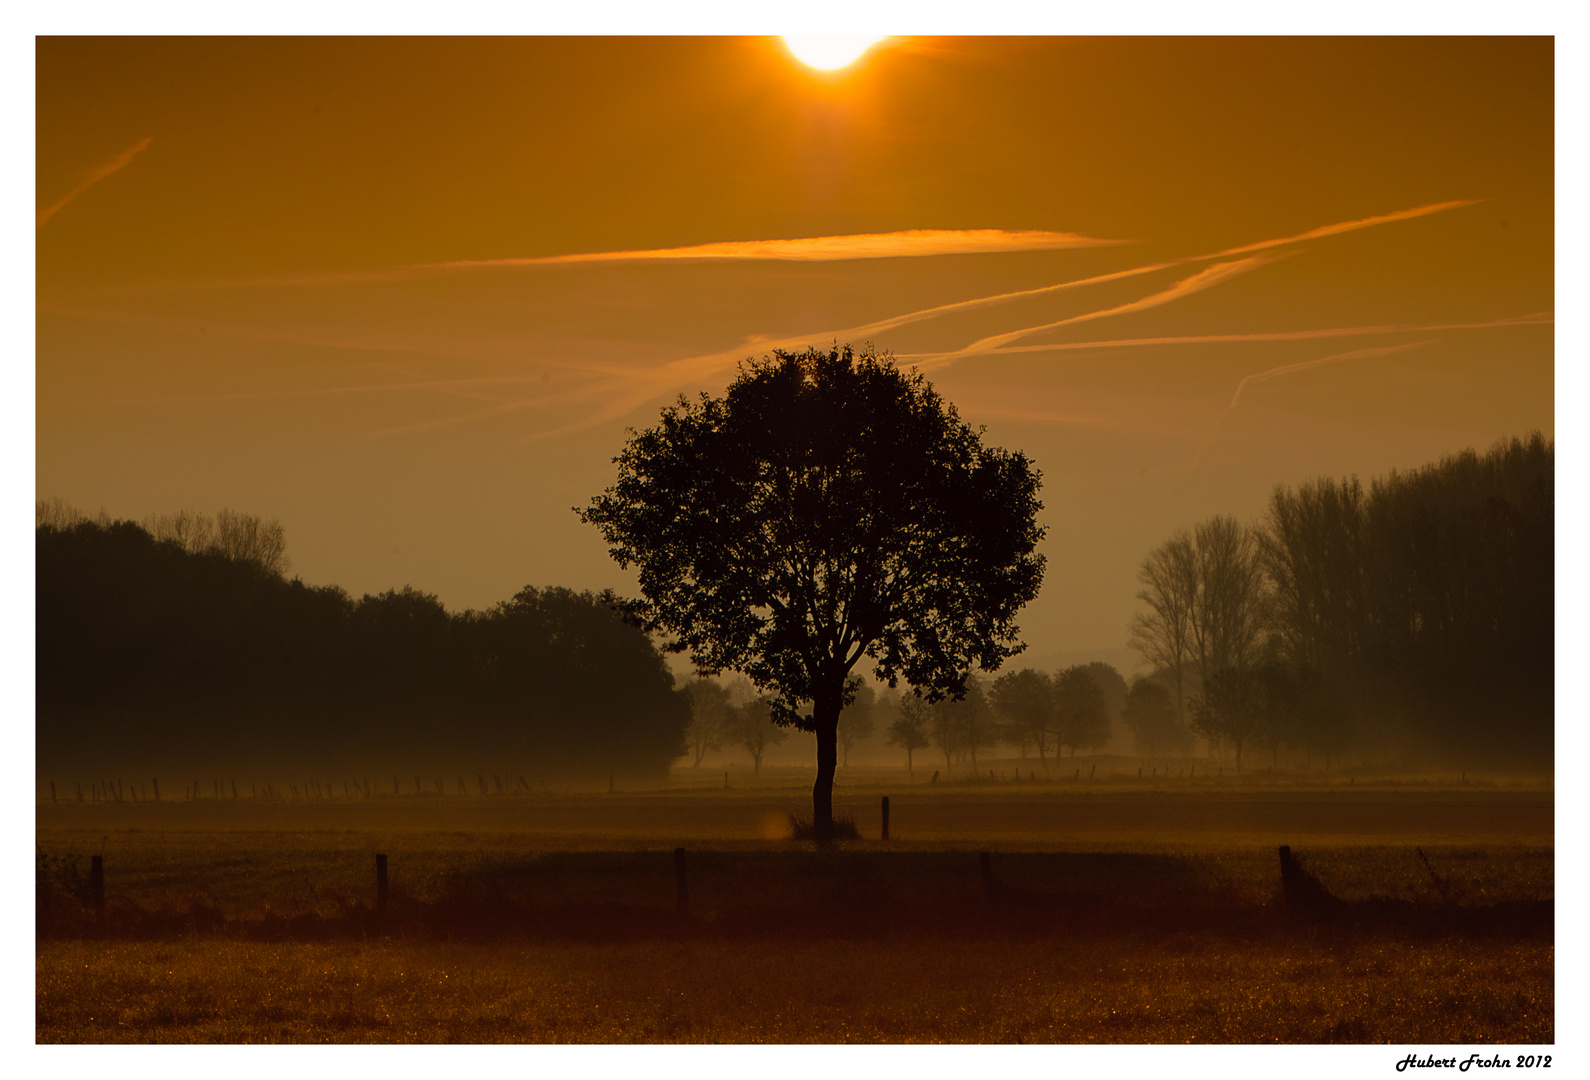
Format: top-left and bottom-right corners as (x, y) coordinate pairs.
(580, 345), (1043, 837)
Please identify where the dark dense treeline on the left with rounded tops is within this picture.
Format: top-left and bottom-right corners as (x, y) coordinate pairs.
(37, 503), (690, 779)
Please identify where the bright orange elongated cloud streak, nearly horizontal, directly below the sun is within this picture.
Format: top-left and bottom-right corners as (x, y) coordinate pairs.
(405, 229), (1124, 270)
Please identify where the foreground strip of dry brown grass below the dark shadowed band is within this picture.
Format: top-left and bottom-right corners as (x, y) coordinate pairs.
(37, 935), (1553, 1045)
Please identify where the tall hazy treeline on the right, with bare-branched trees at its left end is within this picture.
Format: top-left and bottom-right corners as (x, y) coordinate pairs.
(1132, 433), (1555, 765)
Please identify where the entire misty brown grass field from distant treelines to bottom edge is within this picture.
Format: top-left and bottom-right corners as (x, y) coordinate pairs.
(37, 770), (1555, 1043)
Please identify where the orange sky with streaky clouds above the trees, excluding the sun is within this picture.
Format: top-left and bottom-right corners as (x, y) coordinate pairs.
(37, 38), (1555, 666)
